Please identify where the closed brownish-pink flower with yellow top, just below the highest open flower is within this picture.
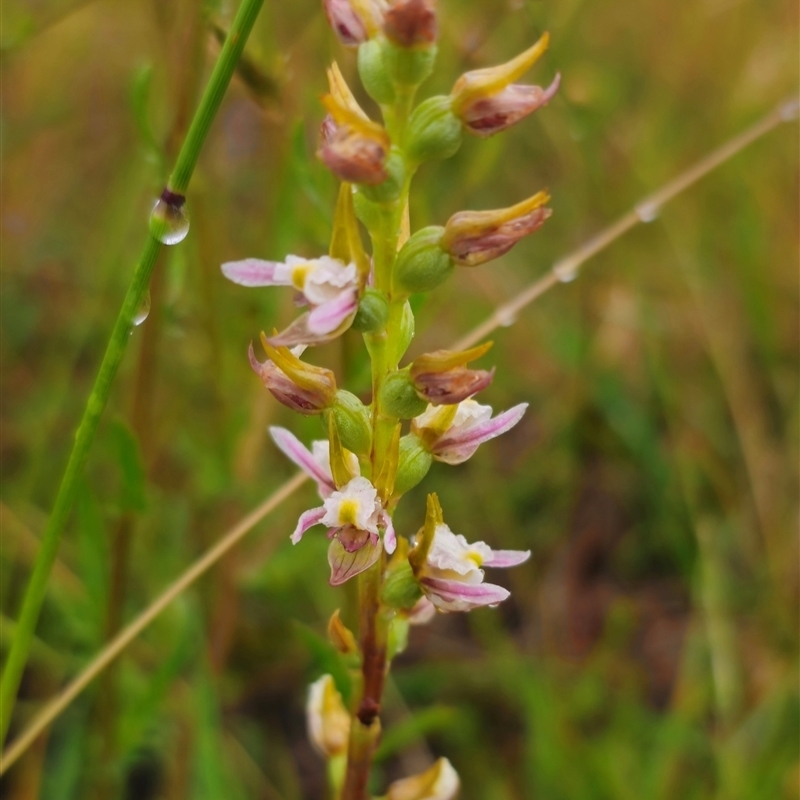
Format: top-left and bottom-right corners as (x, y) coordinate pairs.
(248, 333), (336, 415)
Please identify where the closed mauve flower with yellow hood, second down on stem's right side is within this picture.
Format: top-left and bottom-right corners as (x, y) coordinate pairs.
(442, 192), (552, 267)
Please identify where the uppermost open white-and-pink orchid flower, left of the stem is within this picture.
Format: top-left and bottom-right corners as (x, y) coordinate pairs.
(222, 256), (358, 347)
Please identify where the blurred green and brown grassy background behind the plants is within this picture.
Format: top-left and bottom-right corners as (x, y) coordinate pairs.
(0, 0), (800, 800)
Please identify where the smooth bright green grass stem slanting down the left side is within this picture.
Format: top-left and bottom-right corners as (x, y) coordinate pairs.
(0, 0), (263, 745)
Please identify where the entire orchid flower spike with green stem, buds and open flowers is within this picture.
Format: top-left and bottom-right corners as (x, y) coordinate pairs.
(222, 0), (559, 800)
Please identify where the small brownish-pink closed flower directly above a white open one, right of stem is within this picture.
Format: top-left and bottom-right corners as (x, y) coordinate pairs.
(409, 342), (494, 406)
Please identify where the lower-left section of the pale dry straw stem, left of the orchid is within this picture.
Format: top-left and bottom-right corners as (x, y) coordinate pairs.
(0, 472), (308, 775)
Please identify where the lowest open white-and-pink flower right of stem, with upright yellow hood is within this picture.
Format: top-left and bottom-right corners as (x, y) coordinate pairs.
(408, 494), (531, 611)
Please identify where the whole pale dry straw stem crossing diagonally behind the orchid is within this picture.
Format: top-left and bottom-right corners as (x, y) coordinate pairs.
(0, 98), (798, 775)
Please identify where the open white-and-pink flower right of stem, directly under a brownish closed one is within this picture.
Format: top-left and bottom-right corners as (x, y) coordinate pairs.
(411, 400), (528, 464)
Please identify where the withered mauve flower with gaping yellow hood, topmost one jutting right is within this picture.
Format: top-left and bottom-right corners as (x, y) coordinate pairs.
(450, 33), (561, 138)
